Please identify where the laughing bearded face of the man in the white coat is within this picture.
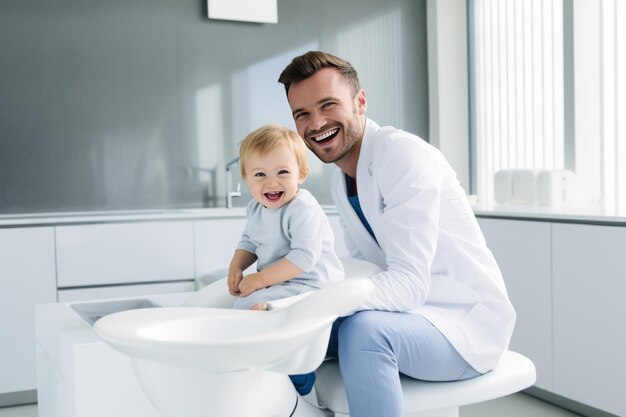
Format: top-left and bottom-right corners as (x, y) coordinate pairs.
(287, 68), (366, 163)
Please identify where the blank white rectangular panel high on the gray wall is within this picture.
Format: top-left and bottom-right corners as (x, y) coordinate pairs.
(207, 0), (278, 23)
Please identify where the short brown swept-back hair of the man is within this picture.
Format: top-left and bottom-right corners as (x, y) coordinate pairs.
(278, 51), (361, 94)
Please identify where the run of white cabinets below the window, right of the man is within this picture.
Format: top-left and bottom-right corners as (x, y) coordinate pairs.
(479, 218), (626, 416)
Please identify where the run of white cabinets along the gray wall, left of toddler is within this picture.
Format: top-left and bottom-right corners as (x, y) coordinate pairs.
(0, 213), (245, 406)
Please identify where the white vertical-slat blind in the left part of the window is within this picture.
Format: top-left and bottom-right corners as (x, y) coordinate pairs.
(473, 0), (564, 204)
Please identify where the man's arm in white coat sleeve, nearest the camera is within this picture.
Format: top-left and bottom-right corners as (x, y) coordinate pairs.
(363, 137), (447, 311)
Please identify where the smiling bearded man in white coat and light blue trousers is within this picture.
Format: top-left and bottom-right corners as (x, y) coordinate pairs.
(278, 51), (515, 417)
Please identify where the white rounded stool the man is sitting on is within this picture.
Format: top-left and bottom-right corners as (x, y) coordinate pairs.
(315, 351), (536, 417)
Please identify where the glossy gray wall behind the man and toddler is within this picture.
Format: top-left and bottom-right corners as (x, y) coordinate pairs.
(0, 0), (428, 214)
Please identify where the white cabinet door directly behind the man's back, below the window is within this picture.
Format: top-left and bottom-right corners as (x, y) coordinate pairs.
(479, 219), (552, 390)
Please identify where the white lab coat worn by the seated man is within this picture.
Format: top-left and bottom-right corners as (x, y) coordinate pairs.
(332, 119), (515, 373)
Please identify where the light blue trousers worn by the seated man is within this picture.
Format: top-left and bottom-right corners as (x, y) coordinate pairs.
(328, 311), (480, 417)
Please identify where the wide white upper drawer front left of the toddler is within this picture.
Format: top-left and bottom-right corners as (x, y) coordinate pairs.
(55, 222), (194, 288)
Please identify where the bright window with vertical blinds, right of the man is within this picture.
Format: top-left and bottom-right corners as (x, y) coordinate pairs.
(470, 0), (626, 216)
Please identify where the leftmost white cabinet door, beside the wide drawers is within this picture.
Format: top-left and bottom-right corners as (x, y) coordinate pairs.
(0, 227), (56, 393)
